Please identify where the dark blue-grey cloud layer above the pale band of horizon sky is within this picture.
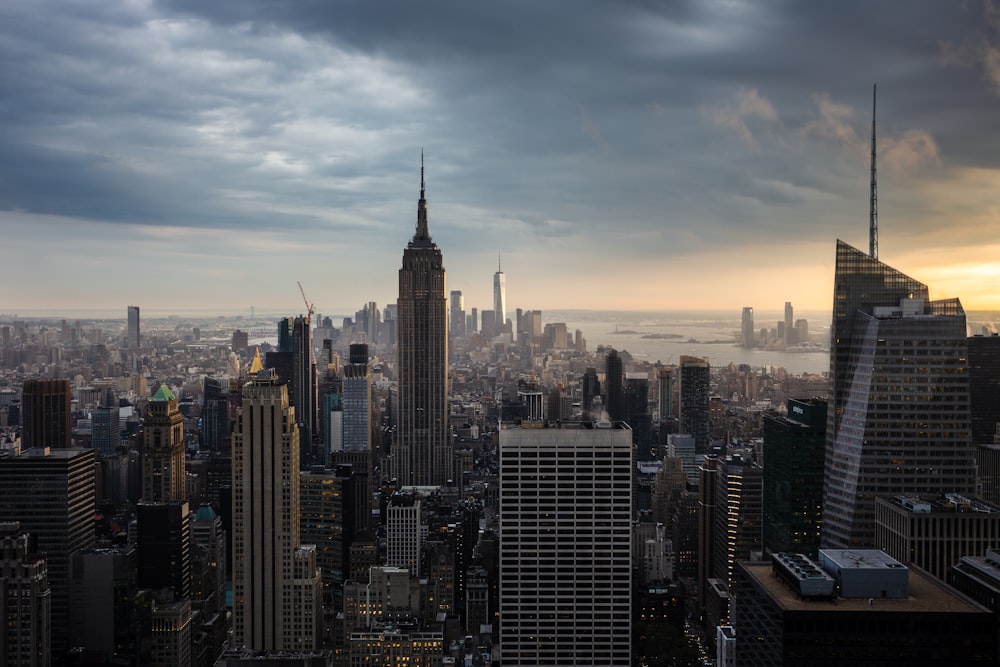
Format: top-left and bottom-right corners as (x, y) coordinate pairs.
(0, 0), (1000, 312)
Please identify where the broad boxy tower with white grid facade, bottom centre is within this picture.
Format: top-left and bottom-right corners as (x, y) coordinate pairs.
(499, 423), (632, 665)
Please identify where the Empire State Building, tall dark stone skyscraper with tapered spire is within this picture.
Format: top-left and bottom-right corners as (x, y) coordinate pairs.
(392, 158), (452, 486)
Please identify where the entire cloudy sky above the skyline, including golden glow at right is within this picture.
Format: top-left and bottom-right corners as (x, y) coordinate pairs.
(0, 0), (1000, 317)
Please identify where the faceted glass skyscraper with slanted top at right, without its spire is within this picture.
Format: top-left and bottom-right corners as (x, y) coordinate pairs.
(822, 241), (976, 549)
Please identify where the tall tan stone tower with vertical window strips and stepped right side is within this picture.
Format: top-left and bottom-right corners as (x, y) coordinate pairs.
(232, 369), (323, 650)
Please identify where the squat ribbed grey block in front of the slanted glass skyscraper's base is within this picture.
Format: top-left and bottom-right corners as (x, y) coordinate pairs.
(875, 493), (1000, 581)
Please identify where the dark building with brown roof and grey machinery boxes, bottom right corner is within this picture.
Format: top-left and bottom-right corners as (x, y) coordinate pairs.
(732, 550), (997, 667)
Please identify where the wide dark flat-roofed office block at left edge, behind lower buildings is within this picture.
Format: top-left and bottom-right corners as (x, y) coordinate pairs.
(0, 447), (96, 662)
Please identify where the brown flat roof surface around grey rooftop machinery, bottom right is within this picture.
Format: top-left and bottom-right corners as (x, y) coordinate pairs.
(740, 561), (991, 614)
